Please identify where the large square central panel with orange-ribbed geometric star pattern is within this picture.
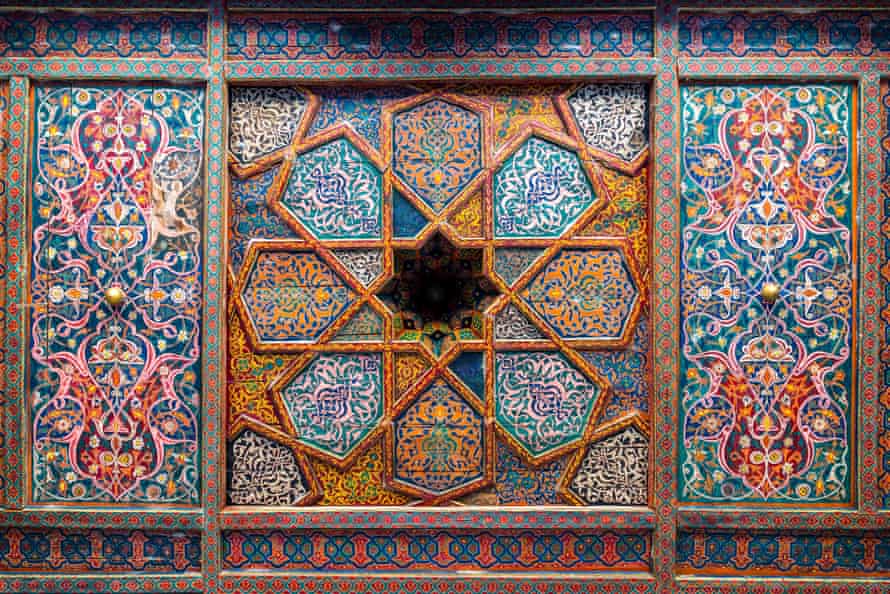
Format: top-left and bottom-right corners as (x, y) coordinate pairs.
(226, 84), (651, 505)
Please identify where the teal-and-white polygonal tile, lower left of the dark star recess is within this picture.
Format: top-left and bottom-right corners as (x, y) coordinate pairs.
(281, 353), (383, 462)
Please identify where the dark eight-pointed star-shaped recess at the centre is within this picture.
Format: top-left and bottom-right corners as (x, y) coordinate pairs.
(379, 233), (498, 356)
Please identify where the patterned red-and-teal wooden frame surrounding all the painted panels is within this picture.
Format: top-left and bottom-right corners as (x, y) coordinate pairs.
(0, 0), (890, 593)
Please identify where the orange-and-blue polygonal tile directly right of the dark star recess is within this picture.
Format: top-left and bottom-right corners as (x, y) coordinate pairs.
(520, 246), (640, 344)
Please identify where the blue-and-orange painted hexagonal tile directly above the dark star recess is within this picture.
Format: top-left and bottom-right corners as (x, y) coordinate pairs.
(393, 99), (482, 212)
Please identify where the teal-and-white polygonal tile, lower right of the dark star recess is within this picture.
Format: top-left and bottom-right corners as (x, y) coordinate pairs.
(495, 351), (605, 462)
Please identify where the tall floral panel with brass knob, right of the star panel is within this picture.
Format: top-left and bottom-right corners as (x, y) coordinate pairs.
(679, 85), (856, 504)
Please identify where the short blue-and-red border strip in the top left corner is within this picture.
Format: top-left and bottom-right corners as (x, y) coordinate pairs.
(0, 11), (207, 59)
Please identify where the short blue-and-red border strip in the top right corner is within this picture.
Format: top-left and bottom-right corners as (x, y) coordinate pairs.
(680, 11), (890, 58)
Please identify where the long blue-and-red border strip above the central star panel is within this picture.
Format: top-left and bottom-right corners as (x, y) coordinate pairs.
(227, 12), (654, 60)
